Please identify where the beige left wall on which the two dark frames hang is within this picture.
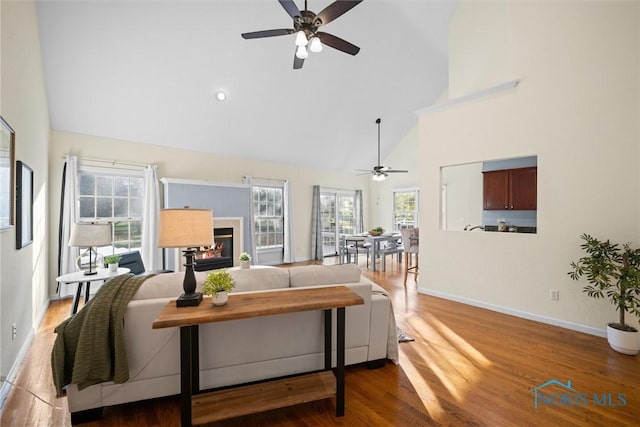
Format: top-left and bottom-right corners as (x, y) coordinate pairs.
(0, 0), (49, 377)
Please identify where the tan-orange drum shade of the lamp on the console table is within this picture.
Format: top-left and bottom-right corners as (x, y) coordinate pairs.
(158, 208), (213, 248)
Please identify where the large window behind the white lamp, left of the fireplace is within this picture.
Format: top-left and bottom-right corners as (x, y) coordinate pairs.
(78, 169), (144, 255)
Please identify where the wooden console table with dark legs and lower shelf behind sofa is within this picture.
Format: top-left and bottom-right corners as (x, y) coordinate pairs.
(153, 286), (364, 426)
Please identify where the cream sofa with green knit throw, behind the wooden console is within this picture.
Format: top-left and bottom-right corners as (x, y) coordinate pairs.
(67, 264), (398, 422)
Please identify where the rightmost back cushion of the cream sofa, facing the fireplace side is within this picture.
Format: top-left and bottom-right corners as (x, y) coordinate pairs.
(289, 264), (361, 288)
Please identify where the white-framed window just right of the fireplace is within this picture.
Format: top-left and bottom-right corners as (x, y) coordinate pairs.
(253, 186), (284, 250)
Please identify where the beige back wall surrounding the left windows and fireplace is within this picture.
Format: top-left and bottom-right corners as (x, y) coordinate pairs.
(49, 132), (369, 294)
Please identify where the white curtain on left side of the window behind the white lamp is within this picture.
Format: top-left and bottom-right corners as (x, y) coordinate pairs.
(59, 156), (79, 275)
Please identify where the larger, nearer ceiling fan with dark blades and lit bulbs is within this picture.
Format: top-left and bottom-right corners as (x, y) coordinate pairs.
(242, 0), (362, 70)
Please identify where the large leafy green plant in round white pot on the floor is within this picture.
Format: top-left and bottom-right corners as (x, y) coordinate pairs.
(568, 234), (640, 355)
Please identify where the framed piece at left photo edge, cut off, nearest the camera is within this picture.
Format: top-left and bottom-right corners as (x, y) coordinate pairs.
(0, 117), (16, 231)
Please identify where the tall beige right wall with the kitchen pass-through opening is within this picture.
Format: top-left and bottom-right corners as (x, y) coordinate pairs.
(419, 1), (640, 334)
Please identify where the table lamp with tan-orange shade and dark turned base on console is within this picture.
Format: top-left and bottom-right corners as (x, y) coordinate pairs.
(158, 208), (213, 307)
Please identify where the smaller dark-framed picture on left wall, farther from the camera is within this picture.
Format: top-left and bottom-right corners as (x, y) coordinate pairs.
(16, 160), (33, 249)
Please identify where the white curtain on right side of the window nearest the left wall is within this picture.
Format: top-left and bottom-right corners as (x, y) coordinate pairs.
(140, 165), (163, 270)
